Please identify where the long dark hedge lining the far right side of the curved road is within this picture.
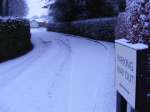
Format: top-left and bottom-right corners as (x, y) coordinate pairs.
(47, 17), (116, 41)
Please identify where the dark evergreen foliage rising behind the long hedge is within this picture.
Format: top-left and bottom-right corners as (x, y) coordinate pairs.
(50, 0), (116, 22)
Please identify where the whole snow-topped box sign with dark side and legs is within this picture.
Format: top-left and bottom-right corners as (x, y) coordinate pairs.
(115, 39), (150, 112)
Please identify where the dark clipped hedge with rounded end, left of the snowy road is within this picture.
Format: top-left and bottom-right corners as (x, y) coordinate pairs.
(0, 18), (32, 62)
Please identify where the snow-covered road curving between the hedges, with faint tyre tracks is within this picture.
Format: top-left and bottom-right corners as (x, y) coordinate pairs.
(0, 29), (116, 112)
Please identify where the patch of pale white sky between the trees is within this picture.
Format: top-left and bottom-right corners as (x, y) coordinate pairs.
(26, 0), (47, 18)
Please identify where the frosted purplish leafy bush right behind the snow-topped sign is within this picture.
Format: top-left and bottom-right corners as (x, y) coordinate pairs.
(115, 0), (150, 44)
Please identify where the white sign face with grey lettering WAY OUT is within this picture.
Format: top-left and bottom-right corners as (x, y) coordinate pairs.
(115, 43), (137, 109)
